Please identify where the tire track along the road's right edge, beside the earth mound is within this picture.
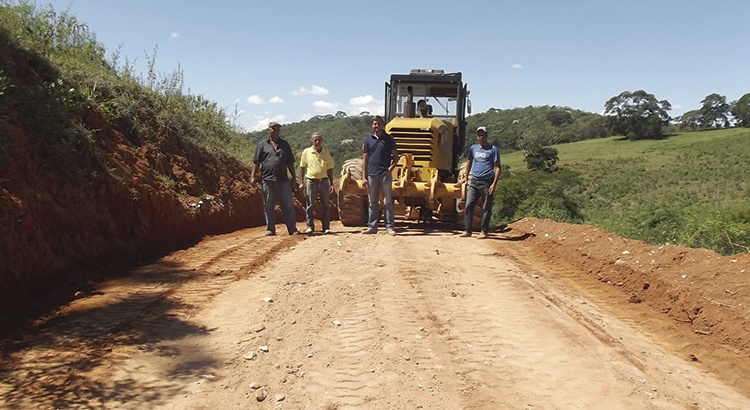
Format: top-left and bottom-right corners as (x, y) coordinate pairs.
(498, 239), (747, 409)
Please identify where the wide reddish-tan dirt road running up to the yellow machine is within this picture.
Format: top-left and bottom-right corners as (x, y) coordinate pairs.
(0, 224), (750, 409)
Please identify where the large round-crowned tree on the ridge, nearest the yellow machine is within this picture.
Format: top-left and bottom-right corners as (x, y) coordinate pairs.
(604, 90), (672, 140)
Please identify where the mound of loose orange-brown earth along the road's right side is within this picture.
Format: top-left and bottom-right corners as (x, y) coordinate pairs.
(510, 218), (750, 354)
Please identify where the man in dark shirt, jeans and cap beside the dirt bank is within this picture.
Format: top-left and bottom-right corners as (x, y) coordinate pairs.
(250, 121), (299, 236)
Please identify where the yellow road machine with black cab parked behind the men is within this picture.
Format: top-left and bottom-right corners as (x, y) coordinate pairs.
(338, 69), (471, 226)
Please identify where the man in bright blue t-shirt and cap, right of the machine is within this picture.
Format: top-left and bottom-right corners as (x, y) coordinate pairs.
(460, 127), (500, 239)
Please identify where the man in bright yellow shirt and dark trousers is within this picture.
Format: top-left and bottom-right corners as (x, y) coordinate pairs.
(299, 132), (333, 234)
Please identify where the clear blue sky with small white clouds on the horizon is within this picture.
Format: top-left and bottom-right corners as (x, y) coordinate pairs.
(36, 0), (750, 131)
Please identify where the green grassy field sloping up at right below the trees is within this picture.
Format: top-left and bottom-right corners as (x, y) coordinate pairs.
(502, 128), (750, 254)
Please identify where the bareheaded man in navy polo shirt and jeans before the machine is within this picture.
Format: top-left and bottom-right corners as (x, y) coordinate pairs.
(362, 115), (398, 235)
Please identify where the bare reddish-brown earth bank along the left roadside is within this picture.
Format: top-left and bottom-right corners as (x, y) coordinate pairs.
(0, 22), (276, 320)
